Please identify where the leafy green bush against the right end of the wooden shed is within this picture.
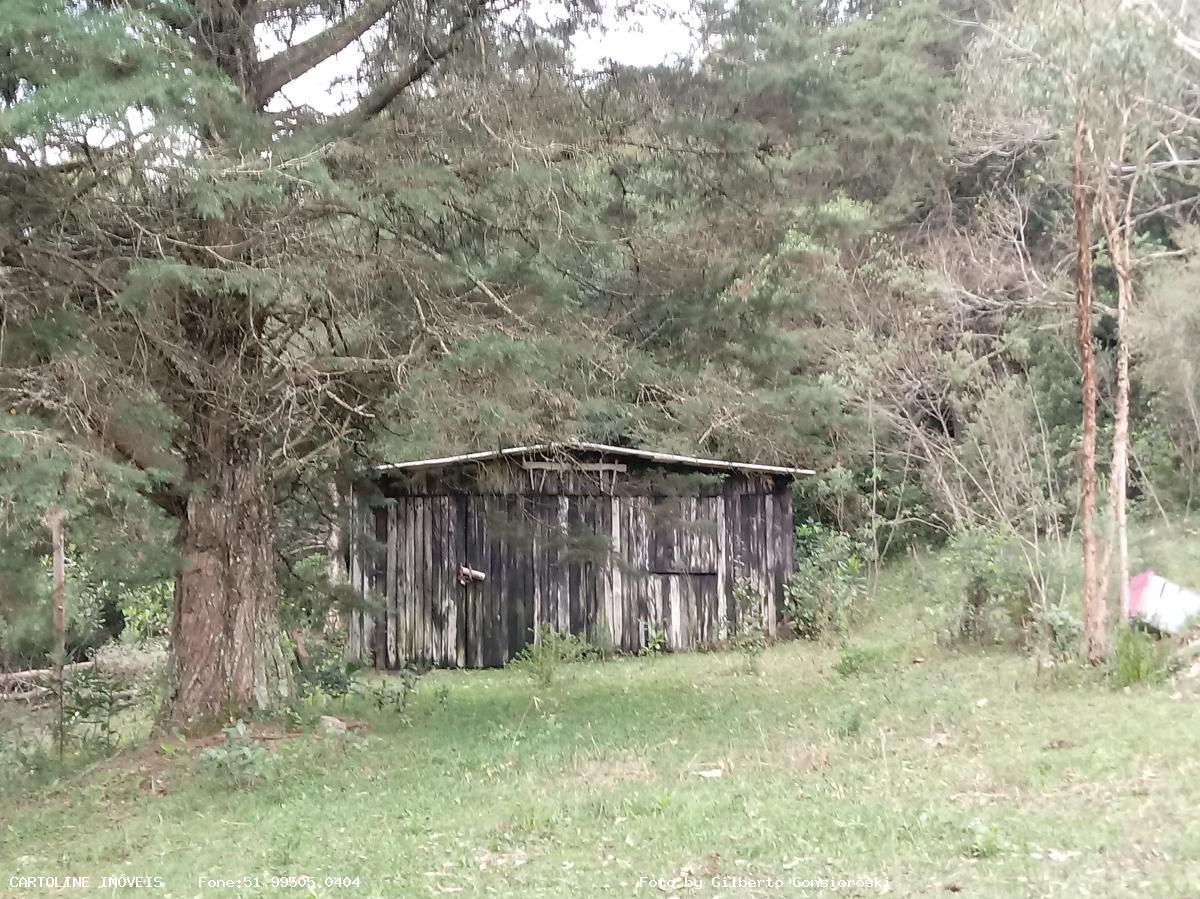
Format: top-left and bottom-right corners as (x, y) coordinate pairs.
(784, 522), (866, 640)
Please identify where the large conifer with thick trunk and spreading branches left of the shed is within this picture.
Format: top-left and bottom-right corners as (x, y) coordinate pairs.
(0, 0), (549, 720)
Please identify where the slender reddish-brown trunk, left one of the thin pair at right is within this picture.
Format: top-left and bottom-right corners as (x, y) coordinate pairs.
(1070, 116), (1108, 665)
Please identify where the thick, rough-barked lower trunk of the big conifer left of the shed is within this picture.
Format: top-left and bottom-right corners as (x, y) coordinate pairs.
(169, 459), (292, 724)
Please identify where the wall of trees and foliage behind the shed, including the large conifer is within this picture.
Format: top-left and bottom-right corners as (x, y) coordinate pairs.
(0, 0), (1200, 715)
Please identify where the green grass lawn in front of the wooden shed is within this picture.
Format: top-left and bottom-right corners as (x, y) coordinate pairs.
(0, 585), (1200, 899)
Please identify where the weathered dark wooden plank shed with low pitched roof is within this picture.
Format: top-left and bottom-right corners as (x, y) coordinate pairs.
(349, 443), (811, 669)
